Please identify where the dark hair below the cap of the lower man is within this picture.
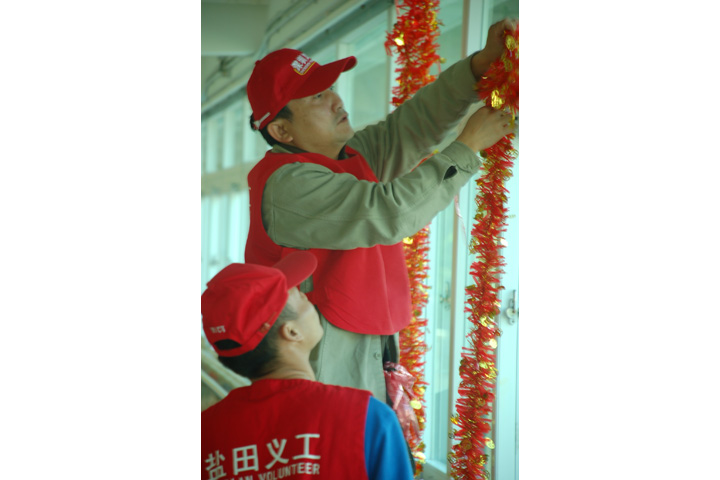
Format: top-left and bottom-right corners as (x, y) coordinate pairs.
(215, 305), (297, 380)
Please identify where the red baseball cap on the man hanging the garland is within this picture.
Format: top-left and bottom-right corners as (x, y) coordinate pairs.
(247, 48), (357, 130)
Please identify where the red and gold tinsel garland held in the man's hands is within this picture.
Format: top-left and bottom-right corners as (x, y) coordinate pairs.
(449, 29), (519, 480)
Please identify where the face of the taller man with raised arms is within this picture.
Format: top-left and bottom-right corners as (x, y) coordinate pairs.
(286, 87), (355, 158)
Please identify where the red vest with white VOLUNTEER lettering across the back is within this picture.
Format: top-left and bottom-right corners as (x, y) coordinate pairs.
(201, 379), (370, 480)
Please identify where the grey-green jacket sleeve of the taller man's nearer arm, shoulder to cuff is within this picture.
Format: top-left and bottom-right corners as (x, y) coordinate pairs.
(262, 142), (480, 250)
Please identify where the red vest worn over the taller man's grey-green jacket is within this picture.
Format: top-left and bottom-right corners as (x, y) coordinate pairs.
(245, 147), (411, 335)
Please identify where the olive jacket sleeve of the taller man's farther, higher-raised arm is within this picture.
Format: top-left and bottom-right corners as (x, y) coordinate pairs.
(348, 57), (479, 182)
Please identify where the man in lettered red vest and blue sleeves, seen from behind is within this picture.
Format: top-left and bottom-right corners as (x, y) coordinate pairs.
(201, 252), (413, 480)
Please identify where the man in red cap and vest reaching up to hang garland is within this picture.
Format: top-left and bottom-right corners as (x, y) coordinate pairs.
(245, 20), (515, 399)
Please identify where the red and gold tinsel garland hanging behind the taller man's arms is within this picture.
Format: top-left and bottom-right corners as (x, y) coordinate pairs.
(385, 0), (441, 475)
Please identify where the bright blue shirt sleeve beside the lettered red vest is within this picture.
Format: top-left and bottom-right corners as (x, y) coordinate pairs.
(365, 397), (413, 480)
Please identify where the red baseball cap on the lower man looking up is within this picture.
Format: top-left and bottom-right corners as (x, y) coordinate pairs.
(200, 251), (317, 357)
